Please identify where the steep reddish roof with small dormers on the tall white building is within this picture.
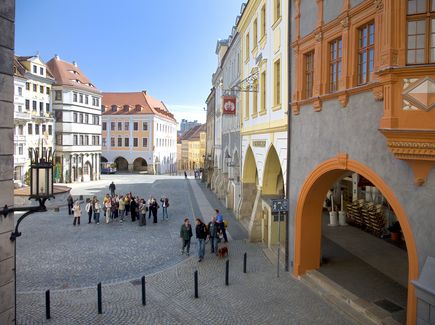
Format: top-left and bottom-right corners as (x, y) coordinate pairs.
(47, 56), (100, 93)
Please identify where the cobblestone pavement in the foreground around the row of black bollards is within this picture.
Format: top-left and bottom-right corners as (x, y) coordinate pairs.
(18, 241), (358, 325)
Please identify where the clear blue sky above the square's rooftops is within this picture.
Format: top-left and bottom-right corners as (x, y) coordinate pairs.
(15, 0), (243, 126)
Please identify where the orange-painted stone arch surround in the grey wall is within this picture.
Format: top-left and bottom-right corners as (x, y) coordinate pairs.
(293, 154), (418, 324)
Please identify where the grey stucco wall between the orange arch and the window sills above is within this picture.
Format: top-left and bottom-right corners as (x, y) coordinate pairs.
(290, 92), (435, 269)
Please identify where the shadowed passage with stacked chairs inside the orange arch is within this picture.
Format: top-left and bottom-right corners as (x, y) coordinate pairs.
(299, 170), (408, 323)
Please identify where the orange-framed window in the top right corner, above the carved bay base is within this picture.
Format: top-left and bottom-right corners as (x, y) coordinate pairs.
(407, 0), (435, 64)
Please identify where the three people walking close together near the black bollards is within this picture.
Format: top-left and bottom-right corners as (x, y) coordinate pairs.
(180, 209), (228, 262)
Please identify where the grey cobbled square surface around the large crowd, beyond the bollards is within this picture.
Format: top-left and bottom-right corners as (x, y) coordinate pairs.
(17, 175), (209, 292)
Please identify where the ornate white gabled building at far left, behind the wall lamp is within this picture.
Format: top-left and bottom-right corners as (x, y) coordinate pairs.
(14, 55), (54, 183)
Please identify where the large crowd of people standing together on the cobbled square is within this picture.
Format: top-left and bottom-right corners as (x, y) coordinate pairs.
(68, 182), (169, 226)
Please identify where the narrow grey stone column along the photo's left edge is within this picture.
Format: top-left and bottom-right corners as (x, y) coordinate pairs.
(0, 0), (16, 324)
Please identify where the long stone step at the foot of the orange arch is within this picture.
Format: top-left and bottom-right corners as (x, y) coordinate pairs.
(300, 270), (400, 325)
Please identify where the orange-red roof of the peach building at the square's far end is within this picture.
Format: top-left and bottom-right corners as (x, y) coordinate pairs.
(103, 91), (175, 121)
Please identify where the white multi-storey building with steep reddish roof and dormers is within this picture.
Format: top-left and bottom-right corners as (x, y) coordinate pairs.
(47, 56), (101, 183)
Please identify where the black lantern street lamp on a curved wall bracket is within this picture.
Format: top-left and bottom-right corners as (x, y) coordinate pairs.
(1, 143), (54, 241)
